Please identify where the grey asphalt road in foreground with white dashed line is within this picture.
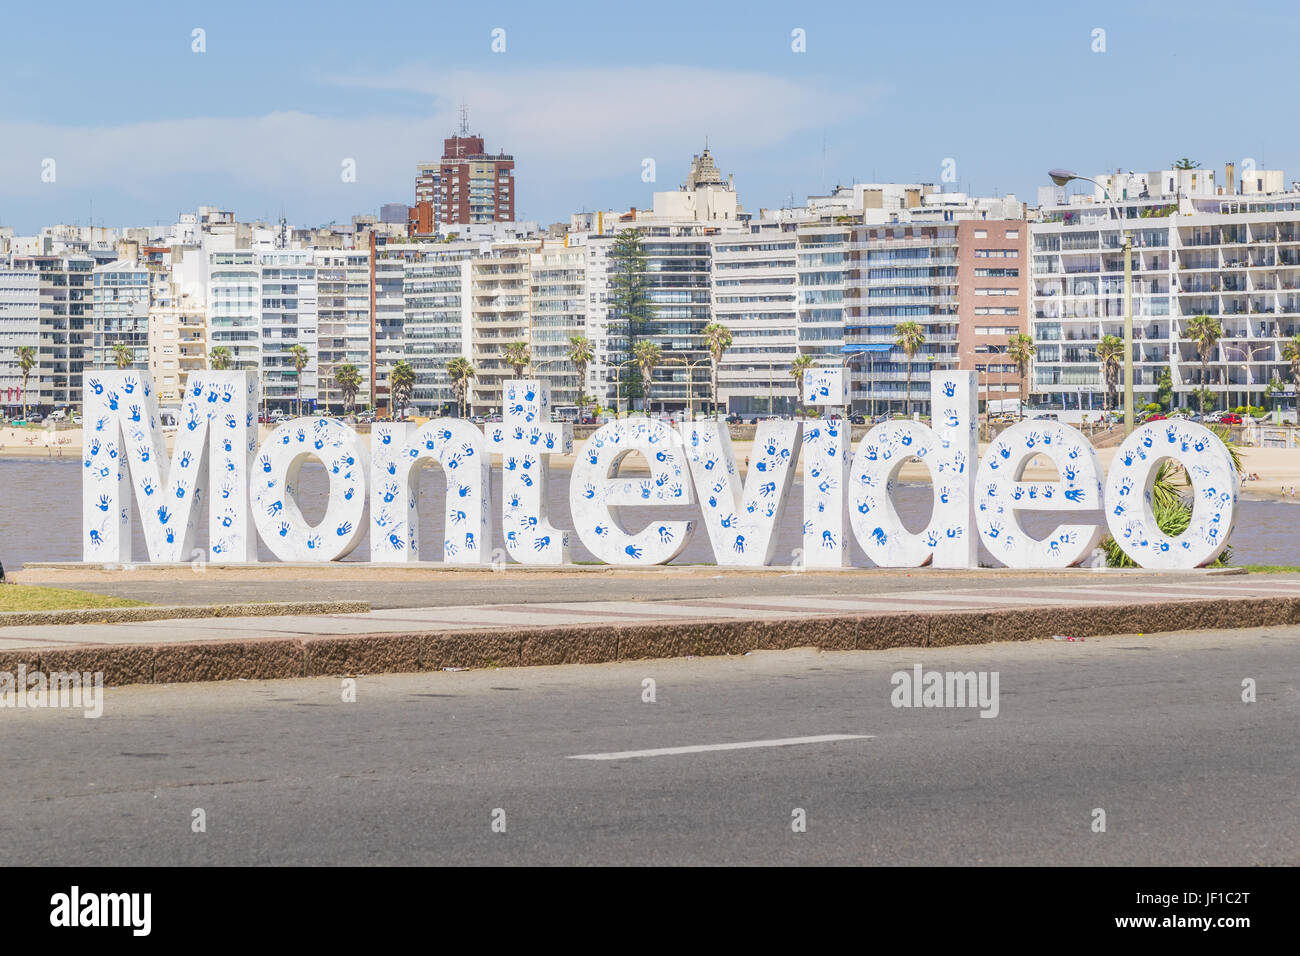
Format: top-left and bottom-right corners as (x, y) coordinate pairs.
(0, 628), (1300, 866)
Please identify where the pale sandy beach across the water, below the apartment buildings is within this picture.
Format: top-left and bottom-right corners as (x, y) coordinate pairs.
(10, 425), (1300, 502)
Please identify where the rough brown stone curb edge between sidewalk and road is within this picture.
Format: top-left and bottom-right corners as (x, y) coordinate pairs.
(0, 597), (1300, 685)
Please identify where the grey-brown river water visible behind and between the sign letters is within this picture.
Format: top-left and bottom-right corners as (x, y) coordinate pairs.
(0, 459), (1300, 570)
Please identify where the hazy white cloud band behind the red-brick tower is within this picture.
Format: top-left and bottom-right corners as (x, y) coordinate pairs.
(0, 66), (879, 217)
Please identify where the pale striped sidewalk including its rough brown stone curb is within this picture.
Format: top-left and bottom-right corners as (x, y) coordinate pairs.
(0, 575), (1300, 684)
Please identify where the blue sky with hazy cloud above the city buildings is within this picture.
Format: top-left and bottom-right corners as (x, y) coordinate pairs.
(0, 0), (1300, 234)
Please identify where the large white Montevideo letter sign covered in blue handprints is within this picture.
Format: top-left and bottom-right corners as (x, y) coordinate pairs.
(82, 371), (1240, 568)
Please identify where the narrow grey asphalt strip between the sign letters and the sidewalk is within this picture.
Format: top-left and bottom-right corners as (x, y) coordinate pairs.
(35, 568), (1291, 610)
